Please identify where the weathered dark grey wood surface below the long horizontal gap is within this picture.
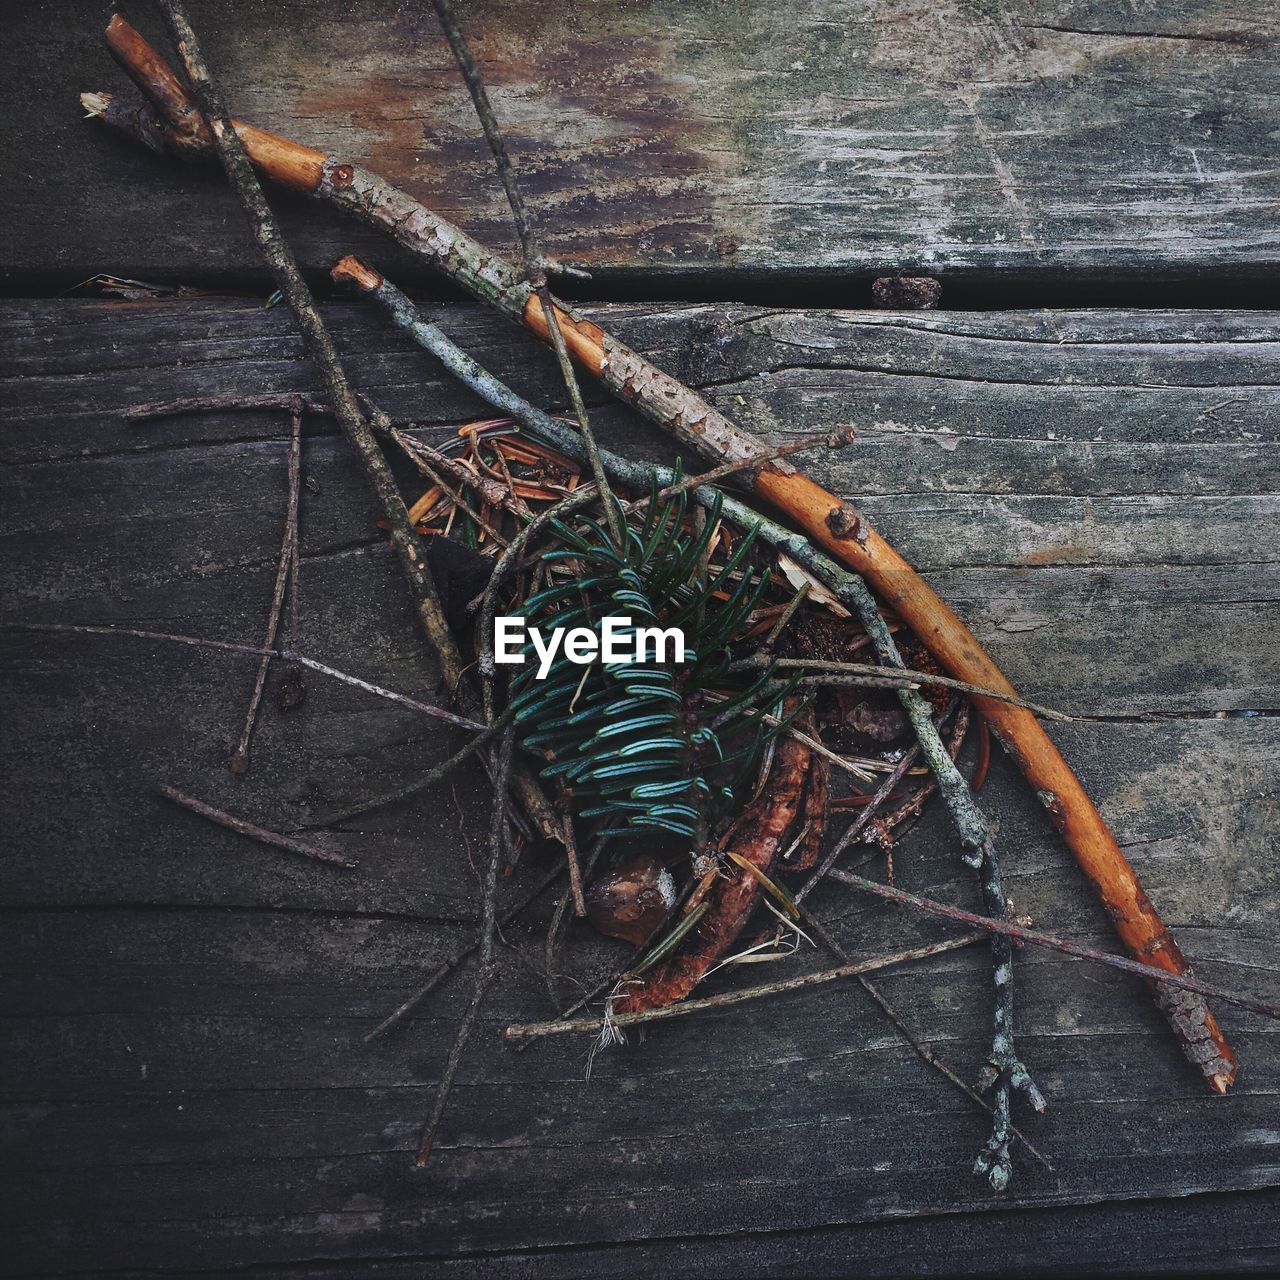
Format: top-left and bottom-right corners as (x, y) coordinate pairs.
(0, 298), (1280, 1276)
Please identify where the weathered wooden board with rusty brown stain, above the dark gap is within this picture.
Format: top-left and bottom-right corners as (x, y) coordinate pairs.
(0, 0), (1280, 290)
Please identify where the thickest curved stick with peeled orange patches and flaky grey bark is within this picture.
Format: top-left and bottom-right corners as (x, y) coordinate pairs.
(82, 17), (1235, 1093)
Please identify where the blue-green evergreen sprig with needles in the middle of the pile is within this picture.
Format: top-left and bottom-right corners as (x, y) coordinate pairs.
(512, 485), (794, 840)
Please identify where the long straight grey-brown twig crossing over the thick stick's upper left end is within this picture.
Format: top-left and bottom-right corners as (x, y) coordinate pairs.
(151, 0), (462, 690)
